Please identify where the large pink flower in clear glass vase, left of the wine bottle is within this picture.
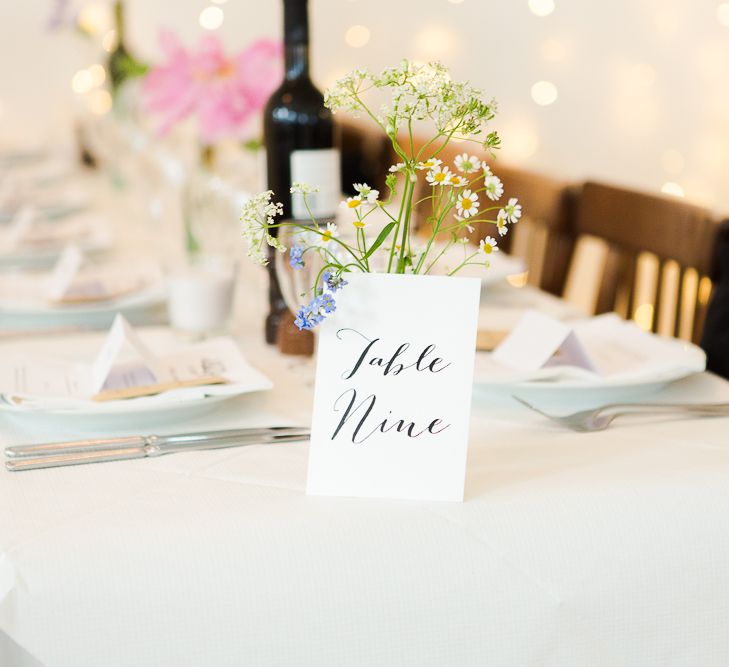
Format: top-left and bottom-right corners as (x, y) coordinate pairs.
(142, 32), (282, 256)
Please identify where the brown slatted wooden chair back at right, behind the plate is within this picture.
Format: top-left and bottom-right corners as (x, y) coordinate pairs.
(575, 182), (718, 341)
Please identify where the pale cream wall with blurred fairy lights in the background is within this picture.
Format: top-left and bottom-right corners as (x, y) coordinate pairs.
(0, 0), (729, 213)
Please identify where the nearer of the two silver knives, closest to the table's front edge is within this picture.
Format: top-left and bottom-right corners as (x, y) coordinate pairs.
(5, 429), (309, 472)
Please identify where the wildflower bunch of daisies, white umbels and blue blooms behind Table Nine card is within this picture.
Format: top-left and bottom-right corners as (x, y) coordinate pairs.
(241, 60), (521, 329)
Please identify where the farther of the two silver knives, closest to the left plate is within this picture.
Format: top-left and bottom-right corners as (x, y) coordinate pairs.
(5, 426), (309, 459)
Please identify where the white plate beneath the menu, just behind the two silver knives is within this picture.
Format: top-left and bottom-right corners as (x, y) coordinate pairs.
(0, 327), (272, 427)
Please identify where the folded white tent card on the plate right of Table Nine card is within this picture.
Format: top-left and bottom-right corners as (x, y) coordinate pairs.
(492, 311), (597, 372)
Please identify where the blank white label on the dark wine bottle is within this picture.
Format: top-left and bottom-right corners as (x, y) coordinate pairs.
(291, 148), (342, 220)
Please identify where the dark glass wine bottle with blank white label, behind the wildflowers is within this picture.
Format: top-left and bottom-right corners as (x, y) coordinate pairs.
(263, 0), (341, 343)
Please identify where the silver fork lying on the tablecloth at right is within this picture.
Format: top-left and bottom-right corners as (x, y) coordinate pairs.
(512, 395), (729, 431)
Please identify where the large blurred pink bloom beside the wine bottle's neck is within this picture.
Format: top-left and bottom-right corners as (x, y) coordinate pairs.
(143, 32), (282, 145)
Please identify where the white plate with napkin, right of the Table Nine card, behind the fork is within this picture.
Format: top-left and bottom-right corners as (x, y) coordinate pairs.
(474, 315), (706, 403)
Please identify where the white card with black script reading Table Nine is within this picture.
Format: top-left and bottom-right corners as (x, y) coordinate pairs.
(307, 274), (481, 501)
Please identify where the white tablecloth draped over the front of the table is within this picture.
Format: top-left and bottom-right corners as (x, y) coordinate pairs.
(0, 322), (729, 667)
